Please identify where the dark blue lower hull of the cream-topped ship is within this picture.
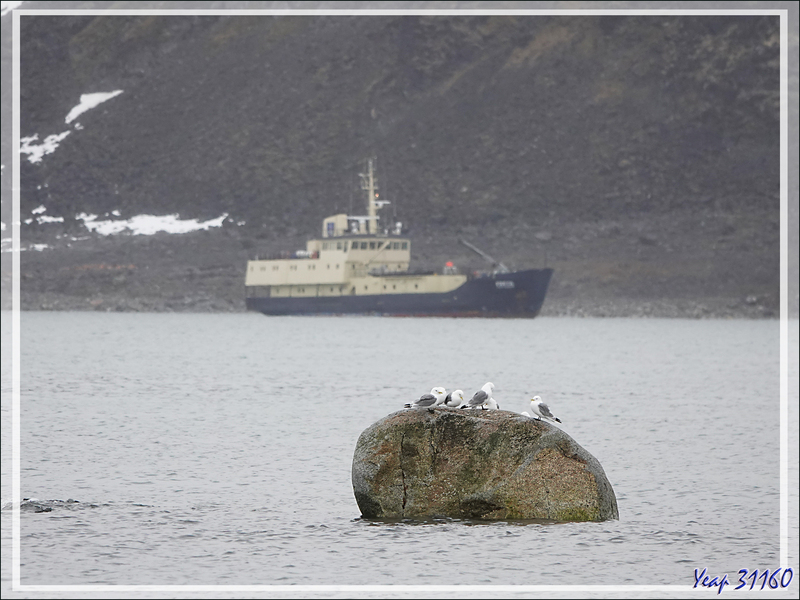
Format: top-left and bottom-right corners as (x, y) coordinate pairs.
(246, 269), (553, 317)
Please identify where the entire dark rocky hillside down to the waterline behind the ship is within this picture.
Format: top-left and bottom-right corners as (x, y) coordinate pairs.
(2, 3), (797, 316)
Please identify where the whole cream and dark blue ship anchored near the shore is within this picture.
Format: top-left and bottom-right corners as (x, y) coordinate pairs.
(245, 159), (553, 317)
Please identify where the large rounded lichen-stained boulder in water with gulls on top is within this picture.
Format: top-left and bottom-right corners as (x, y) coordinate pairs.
(352, 407), (619, 521)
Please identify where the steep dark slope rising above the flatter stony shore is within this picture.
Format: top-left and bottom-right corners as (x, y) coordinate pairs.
(14, 16), (779, 231)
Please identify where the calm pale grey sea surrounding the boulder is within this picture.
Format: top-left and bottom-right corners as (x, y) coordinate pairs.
(2, 312), (797, 596)
